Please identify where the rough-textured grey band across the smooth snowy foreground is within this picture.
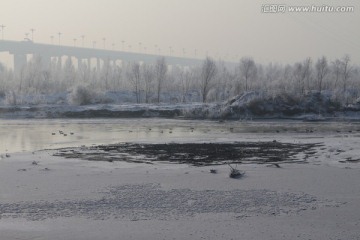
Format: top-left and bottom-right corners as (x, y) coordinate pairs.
(0, 184), (335, 221)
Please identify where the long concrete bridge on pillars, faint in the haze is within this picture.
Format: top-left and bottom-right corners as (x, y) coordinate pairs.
(0, 40), (203, 72)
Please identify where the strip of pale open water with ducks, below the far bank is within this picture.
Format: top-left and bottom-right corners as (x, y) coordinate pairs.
(0, 119), (360, 154)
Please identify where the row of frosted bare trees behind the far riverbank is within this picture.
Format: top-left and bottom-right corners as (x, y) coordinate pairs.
(0, 56), (360, 104)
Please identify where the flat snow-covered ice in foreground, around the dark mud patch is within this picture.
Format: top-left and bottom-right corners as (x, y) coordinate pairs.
(0, 120), (360, 240)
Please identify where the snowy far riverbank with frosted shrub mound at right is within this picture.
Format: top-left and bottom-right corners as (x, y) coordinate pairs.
(0, 92), (360, 121)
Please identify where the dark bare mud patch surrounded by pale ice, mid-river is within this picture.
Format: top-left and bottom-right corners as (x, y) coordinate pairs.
(54, 141), (321, 166)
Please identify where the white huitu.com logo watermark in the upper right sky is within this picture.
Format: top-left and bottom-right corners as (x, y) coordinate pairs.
(261, 4), (355, 13)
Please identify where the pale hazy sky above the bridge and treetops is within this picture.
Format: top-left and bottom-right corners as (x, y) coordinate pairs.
(0, 0), (360, 64)
